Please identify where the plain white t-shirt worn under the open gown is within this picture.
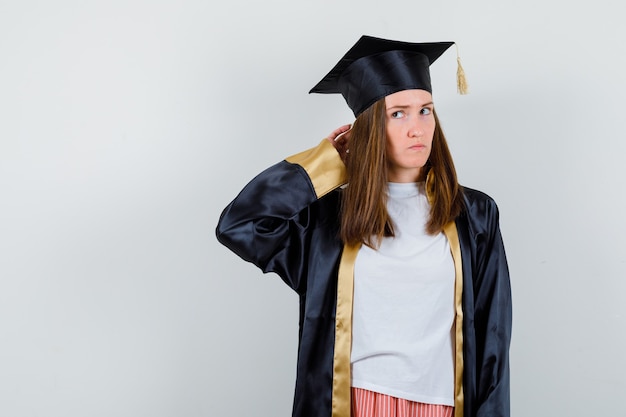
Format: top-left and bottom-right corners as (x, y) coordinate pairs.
(351, 183), (455, 406)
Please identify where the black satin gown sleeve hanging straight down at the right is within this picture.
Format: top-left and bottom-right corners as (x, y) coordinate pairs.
(474, 199), (512, 417)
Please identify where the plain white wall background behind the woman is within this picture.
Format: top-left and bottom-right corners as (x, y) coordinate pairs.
(0, 0), (626, 417)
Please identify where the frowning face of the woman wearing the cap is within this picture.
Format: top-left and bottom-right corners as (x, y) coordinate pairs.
(385, 90), (435, 182)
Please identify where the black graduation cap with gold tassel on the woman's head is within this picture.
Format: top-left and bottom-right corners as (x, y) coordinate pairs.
(309, 35), (467, 116)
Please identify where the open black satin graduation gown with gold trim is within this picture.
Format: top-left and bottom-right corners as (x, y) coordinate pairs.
(216, 140), (511, 417)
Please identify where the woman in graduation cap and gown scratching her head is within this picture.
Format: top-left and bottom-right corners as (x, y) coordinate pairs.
(216, 36), (511, 417)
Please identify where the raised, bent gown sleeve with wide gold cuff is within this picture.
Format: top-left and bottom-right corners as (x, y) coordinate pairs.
(216, 139), (345, 292)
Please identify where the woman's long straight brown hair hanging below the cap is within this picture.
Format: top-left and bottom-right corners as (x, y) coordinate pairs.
(341, 98), (463, 247)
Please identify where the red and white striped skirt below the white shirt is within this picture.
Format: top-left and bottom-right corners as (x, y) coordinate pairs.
(352, 387), (454, 417)
